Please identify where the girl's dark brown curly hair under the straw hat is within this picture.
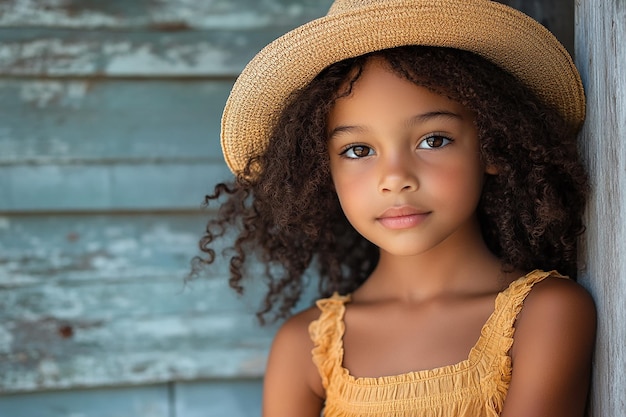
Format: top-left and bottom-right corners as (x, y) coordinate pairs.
(192, 46), (588, 323)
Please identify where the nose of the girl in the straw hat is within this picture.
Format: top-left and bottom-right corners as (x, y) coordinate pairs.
(379, 152), (419, 193)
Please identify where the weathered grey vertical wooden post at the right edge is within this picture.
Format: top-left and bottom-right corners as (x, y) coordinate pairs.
(576, 0), (626, 417)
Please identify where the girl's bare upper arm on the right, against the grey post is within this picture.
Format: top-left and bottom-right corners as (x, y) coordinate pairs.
(501, 278), (596, 417)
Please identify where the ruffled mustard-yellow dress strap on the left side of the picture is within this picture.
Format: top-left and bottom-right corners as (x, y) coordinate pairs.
(309, 293), (350, 389)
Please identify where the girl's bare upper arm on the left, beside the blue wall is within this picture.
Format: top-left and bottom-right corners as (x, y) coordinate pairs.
(263, 308), (324, 417)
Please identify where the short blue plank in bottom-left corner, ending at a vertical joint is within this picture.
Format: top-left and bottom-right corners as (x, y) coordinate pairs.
(0, 385), (168, 417)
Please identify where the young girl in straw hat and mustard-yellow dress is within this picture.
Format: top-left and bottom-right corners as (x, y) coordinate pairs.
(195, 0), (595, 417)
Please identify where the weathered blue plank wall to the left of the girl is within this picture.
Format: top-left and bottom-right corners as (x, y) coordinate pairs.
(0, 0), (330, 417)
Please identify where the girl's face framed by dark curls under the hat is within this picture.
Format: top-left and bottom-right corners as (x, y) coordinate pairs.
(328, 59), (485, 255)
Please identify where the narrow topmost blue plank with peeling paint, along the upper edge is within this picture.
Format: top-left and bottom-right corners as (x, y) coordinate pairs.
(0, 0), (332, 31)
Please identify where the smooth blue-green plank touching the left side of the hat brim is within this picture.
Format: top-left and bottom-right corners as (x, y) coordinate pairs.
(0, 79), (232, 165)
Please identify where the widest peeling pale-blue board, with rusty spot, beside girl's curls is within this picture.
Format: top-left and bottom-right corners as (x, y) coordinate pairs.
(0, 214), (282, 393)
